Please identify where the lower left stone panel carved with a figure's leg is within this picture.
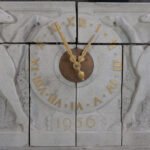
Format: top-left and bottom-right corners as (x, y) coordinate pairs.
(0, 44), (29, 146)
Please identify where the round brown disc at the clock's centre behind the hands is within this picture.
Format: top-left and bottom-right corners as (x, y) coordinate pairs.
(59, 48), (94, 82)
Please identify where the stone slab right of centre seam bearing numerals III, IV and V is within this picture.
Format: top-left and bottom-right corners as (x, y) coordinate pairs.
(77, 45), (122, 146)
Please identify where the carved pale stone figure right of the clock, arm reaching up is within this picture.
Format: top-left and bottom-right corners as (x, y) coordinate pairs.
(116, 15), (150, 131)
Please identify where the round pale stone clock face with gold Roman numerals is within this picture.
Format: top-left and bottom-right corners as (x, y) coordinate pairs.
(30, 15), (122, 113)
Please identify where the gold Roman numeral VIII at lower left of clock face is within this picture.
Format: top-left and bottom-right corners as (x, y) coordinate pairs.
(33, 76), (46, 95)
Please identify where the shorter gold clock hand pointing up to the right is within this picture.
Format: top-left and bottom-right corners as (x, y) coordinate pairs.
(78, 24), (100, 63)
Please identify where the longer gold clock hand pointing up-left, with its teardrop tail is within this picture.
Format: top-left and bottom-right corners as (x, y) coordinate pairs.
(55, 22), (84, 80)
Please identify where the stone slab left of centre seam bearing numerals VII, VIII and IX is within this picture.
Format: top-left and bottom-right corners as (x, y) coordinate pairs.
(30, 45), (76, 146)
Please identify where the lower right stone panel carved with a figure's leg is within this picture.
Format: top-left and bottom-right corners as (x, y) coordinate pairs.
(122, 45), (150, 146)
